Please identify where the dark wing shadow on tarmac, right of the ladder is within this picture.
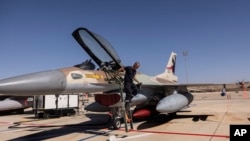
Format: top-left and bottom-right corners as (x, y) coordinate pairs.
(137, 114), (214, 130)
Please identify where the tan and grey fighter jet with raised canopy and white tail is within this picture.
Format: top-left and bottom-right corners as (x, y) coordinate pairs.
(0, 28), (227, 128)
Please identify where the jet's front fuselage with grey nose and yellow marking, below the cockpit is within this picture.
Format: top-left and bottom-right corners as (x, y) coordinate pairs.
(0, 67), (119, 95)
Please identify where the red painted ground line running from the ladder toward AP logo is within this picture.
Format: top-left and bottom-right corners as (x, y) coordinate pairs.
(119, 129), (230, 138)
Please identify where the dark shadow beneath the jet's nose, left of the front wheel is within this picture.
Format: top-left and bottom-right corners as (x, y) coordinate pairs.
(6, 114), (114, 141)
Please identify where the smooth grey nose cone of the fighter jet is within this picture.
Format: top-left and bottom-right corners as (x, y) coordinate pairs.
(0, 70), (66, 95)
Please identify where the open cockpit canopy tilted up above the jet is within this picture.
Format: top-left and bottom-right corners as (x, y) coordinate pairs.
(72, 28), (122, 70)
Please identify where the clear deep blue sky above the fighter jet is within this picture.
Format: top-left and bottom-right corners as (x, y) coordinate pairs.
(0, 0), (250, 83)
